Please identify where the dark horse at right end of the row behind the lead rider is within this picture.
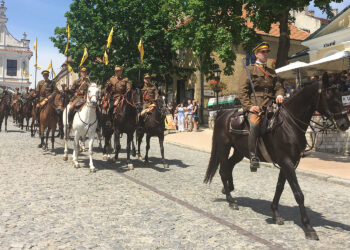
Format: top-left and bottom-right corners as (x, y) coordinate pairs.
(136, 97), (169, 168)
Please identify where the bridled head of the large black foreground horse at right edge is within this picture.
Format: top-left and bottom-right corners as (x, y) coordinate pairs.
(317, 72), (350, 131)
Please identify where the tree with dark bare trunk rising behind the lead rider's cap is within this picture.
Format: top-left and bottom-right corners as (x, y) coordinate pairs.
(244, 0), (343, 68)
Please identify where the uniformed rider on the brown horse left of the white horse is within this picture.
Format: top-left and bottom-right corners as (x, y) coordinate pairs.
(35, 70), (58, 120)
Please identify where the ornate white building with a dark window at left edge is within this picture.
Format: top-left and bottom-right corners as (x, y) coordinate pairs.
(0, 0), (33, 90)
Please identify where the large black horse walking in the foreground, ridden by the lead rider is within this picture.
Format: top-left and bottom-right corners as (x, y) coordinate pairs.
(204, 73), (350, 240)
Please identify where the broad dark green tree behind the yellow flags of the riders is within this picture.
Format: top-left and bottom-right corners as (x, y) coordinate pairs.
(51, 0), (182, 86)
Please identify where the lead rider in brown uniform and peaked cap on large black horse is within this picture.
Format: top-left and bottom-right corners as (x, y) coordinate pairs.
(239, 42), (284, 172)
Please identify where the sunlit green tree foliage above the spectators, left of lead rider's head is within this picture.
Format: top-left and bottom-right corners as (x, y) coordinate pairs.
(166, 0), (259, 75)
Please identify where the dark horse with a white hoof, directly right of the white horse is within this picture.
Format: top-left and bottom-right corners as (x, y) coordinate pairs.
(113, 88), (142, 170)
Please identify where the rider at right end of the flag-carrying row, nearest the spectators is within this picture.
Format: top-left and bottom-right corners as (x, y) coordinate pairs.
(141, 73), (158, 117)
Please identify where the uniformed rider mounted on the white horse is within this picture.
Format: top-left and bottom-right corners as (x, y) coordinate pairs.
(68, 67), (90, 128)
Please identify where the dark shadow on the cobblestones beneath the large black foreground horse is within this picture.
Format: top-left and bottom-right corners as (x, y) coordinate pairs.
(214, 197), (350, 234)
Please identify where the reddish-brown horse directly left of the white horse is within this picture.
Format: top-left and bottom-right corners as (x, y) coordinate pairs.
(38, 93), (64, 151)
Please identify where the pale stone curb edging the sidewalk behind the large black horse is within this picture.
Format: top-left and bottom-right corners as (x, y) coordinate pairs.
(164, 141), (350, 187)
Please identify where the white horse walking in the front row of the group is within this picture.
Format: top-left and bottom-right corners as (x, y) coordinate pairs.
(63, 83), (100, 172)
